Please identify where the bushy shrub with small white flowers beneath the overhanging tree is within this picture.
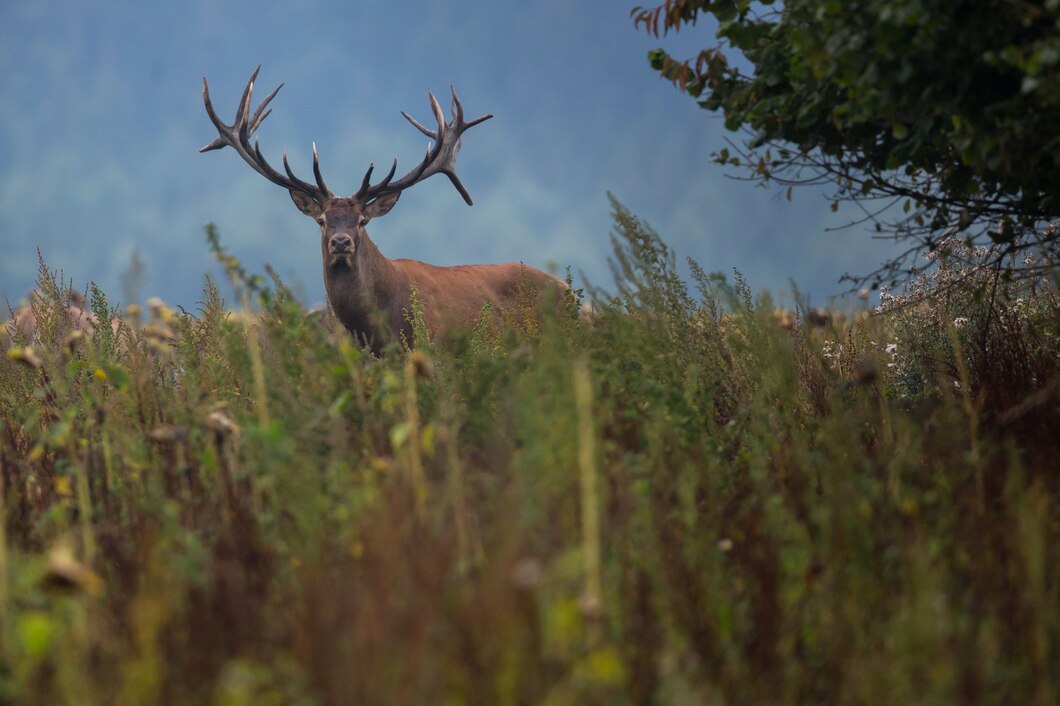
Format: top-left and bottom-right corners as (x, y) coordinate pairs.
(879, 237), (1060, 443)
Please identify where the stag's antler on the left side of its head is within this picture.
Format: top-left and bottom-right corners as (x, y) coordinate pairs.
(199, 64), (334, 204)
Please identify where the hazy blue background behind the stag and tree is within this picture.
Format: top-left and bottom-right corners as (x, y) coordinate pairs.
(0, 0), (894, 311)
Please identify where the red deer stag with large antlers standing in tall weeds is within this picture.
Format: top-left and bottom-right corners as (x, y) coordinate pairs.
(199, 66), (567, 354)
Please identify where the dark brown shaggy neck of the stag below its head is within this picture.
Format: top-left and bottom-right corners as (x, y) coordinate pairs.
(323, 235), (409, 354)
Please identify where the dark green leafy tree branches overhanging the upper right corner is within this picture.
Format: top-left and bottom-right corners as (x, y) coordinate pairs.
(632, 0), (1060, 284)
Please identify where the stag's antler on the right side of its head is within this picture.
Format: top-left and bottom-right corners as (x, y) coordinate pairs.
(353, 86), (493, 206)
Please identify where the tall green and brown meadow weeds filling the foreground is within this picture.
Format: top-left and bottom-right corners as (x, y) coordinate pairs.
(0, 204), (1060, 706)
